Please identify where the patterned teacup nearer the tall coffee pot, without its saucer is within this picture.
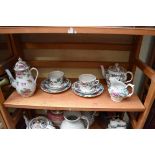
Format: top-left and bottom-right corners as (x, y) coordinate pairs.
(48, 71), (64, 87)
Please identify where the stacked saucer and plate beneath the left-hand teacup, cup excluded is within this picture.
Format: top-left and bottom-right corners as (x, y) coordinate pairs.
(40, 79), (71, 94)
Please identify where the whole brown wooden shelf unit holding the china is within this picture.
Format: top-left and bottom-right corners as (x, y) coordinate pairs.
(0, 27), (155, 128)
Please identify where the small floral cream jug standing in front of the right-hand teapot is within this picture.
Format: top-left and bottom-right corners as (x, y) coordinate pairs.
(108, 77), (134, 102)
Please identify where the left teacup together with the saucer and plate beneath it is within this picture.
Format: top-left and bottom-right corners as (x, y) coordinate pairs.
(40, 71), (71, 93)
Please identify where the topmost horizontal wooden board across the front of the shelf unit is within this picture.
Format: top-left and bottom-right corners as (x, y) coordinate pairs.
(0, 26), (155, 35)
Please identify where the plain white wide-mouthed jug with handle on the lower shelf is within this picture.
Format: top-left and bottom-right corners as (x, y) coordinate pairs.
(60, 111), (89, 129)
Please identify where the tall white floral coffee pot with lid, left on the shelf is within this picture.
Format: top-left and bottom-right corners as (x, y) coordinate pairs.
(5, 58), (38, 97)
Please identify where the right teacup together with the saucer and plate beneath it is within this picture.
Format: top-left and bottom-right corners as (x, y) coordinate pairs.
(72, 74), (104, 97)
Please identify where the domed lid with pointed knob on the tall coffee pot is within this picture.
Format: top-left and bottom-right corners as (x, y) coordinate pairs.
(14, 58), (29, 71)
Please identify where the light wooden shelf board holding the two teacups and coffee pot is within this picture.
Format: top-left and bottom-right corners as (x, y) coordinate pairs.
(4, 80), (145, 112)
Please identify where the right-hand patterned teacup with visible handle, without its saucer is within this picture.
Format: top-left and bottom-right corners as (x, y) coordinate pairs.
(79, 74), (99, 92)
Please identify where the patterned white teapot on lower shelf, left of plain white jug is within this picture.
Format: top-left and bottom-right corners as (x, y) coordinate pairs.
(24, 116), (55, 129)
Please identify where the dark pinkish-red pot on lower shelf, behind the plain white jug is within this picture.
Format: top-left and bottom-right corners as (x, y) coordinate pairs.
(47, 110), (64, 127)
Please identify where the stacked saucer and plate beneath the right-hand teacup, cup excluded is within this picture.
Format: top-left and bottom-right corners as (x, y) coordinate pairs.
(72, 82), (104, 97)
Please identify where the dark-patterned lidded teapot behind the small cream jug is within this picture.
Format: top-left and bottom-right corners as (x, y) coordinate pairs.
(101, 63), (133, 86)
